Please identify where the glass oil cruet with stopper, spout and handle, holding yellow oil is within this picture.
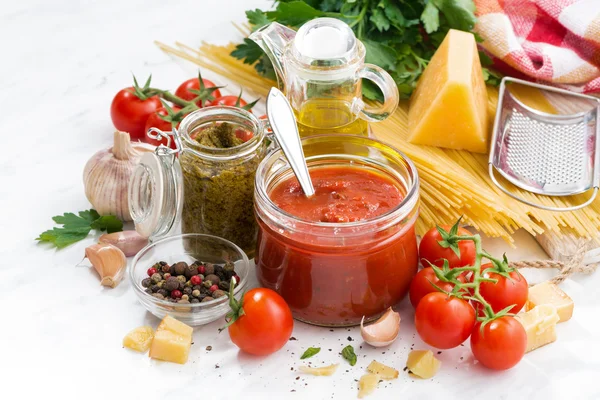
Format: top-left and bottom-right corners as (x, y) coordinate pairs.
(250, 18), (398, 137)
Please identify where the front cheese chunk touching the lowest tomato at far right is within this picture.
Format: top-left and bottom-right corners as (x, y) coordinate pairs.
(515, 304), (559, 353)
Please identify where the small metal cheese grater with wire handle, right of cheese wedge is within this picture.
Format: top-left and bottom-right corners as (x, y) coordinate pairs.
(489, 77), (600, 211)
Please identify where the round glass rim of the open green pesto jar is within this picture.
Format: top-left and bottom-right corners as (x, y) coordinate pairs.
(174, 106), (266, 160)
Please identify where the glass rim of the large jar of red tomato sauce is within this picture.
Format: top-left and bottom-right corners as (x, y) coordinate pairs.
(255, 134), (419, 233)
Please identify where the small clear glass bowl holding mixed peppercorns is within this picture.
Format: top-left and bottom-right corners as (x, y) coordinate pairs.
(129, 233), (249, 326)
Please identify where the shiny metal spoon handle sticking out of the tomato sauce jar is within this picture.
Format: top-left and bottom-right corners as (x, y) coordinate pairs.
(267, 88), (315, 197)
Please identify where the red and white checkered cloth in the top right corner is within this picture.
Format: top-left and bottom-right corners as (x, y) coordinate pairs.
(475, 0), (600, 93)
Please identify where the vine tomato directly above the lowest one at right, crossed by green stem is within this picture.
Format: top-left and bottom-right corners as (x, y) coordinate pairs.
(478, 264), (529, 314)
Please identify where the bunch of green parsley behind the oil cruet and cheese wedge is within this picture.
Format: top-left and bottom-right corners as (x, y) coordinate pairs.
(231, 0), (499, 100)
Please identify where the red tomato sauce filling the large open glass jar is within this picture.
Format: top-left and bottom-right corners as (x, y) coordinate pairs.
(255, 166), (418, 326)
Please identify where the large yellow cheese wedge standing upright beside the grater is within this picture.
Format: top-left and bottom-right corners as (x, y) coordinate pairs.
(408, 29), (489, 153)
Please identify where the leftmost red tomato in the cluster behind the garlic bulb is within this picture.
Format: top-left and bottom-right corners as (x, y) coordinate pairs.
(110, 87), (162, 140)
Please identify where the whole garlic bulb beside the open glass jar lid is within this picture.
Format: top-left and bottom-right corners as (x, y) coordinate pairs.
(83, 131), (155, 221)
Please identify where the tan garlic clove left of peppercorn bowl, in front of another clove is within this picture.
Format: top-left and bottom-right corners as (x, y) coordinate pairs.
(85, 243), (127, 288)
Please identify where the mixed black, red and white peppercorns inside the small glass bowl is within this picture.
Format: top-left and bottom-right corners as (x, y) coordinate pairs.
(142, 261), (240, 304)
